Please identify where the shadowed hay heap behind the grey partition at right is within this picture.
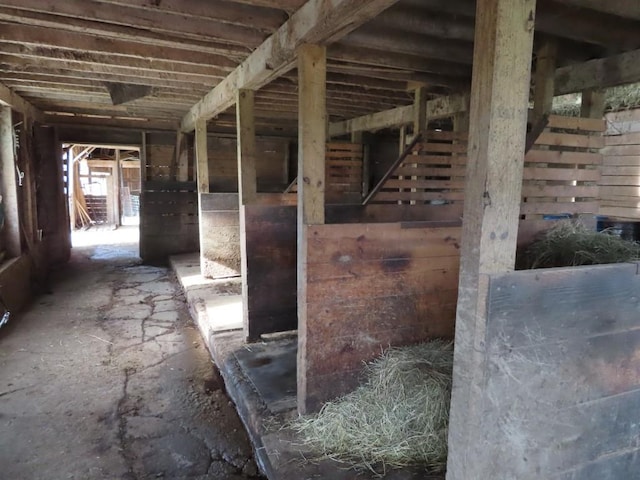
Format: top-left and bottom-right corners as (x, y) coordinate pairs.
(524, 220), (640, 268)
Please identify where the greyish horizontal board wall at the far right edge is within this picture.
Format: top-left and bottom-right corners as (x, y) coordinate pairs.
(600, 109), (640, 220)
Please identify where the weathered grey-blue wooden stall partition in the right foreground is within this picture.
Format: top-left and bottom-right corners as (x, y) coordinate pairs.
(449, 264), (640, 480)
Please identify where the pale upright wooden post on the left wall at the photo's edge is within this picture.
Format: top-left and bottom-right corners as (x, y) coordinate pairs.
(0, 106), (22, 257)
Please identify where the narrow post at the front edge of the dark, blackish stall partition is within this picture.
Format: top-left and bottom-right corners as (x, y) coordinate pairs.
(236, 90), (258, 341)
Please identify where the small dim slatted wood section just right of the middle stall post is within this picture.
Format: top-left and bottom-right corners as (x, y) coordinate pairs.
(289, 142), (364, 205)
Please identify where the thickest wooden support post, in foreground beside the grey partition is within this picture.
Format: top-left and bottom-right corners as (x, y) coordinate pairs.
(447, 0), (536, 480)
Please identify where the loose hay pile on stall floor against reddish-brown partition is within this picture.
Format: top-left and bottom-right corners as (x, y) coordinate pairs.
(291, 341), (453, 471)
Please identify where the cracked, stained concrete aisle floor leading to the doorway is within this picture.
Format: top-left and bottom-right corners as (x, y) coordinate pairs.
(0, 230), (260, 480)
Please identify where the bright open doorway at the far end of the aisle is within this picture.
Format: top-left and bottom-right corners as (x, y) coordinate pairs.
(63, 143), (141, 256)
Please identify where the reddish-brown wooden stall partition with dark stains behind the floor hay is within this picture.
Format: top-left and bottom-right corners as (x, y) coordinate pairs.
(298, 223), (460, 410)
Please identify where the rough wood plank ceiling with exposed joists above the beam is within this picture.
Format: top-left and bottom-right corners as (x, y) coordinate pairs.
(0, 0), (640, 131)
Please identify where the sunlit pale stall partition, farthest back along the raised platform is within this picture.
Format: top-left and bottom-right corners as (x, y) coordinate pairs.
(196, 193), (241, 278)
